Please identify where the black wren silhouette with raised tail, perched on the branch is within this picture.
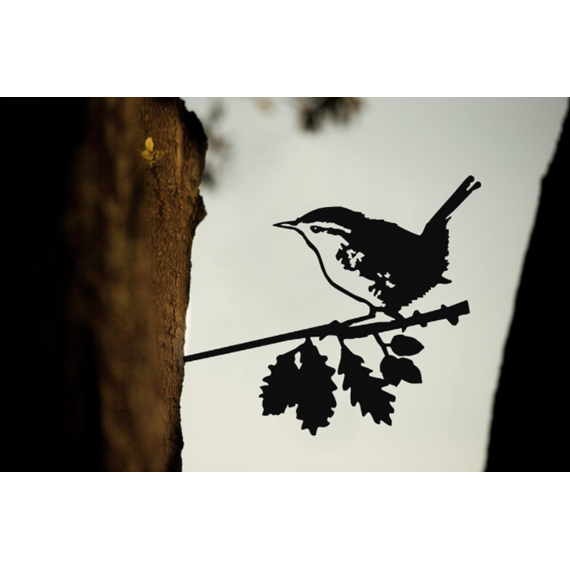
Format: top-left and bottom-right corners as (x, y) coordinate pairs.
(275, 176), (481, 322)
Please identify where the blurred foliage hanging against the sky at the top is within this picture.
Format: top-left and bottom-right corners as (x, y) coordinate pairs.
(189, 97), (363, 188)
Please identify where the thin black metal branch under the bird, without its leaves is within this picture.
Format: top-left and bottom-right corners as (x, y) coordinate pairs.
(184, 301), (471, 363)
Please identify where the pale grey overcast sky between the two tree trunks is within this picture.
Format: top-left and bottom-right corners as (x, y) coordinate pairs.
(182, 97), (567, 472)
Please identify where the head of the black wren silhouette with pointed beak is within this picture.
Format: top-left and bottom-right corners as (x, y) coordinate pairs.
(275, 208), (365, 255)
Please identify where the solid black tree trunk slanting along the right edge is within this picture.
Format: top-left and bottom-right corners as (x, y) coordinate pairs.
(487, 102), (570, 475)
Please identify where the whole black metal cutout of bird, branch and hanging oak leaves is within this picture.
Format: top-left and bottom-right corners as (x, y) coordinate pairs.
(184, 176), (481, 436)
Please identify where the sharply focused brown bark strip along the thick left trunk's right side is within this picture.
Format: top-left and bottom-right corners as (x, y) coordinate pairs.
(139, 97), (206, 471)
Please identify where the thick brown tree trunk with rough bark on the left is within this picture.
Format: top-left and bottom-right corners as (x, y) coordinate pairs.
(3, 97), (206, 472)
